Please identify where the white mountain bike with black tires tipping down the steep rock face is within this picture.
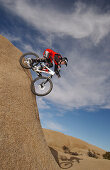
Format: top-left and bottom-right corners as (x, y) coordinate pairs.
(19, 52), (55, 96)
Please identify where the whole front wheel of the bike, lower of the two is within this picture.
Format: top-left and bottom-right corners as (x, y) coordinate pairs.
(31, 77), (53, 96)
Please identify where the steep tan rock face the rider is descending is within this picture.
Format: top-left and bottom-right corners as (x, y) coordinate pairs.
(0, 35), (59, 170)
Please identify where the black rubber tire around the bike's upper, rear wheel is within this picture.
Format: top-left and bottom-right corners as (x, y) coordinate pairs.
(19, 52), (39, 69)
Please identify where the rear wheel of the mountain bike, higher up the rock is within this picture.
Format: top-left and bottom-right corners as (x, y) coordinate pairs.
(19, 52), (39, 69)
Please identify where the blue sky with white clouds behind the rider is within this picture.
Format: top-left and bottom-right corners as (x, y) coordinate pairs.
(0, 0), (110, 151)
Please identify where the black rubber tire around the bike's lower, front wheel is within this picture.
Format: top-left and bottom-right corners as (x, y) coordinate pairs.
(31, 76), (53, 96)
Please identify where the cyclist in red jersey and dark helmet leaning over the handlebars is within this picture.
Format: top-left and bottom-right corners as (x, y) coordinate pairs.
(32, 49), (68, 77)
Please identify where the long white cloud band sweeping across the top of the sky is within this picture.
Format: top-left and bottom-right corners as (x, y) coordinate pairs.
(2, 0), (110, 43)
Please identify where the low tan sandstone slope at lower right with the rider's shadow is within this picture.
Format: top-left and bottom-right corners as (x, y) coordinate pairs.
(43, 129), (110, 170)
